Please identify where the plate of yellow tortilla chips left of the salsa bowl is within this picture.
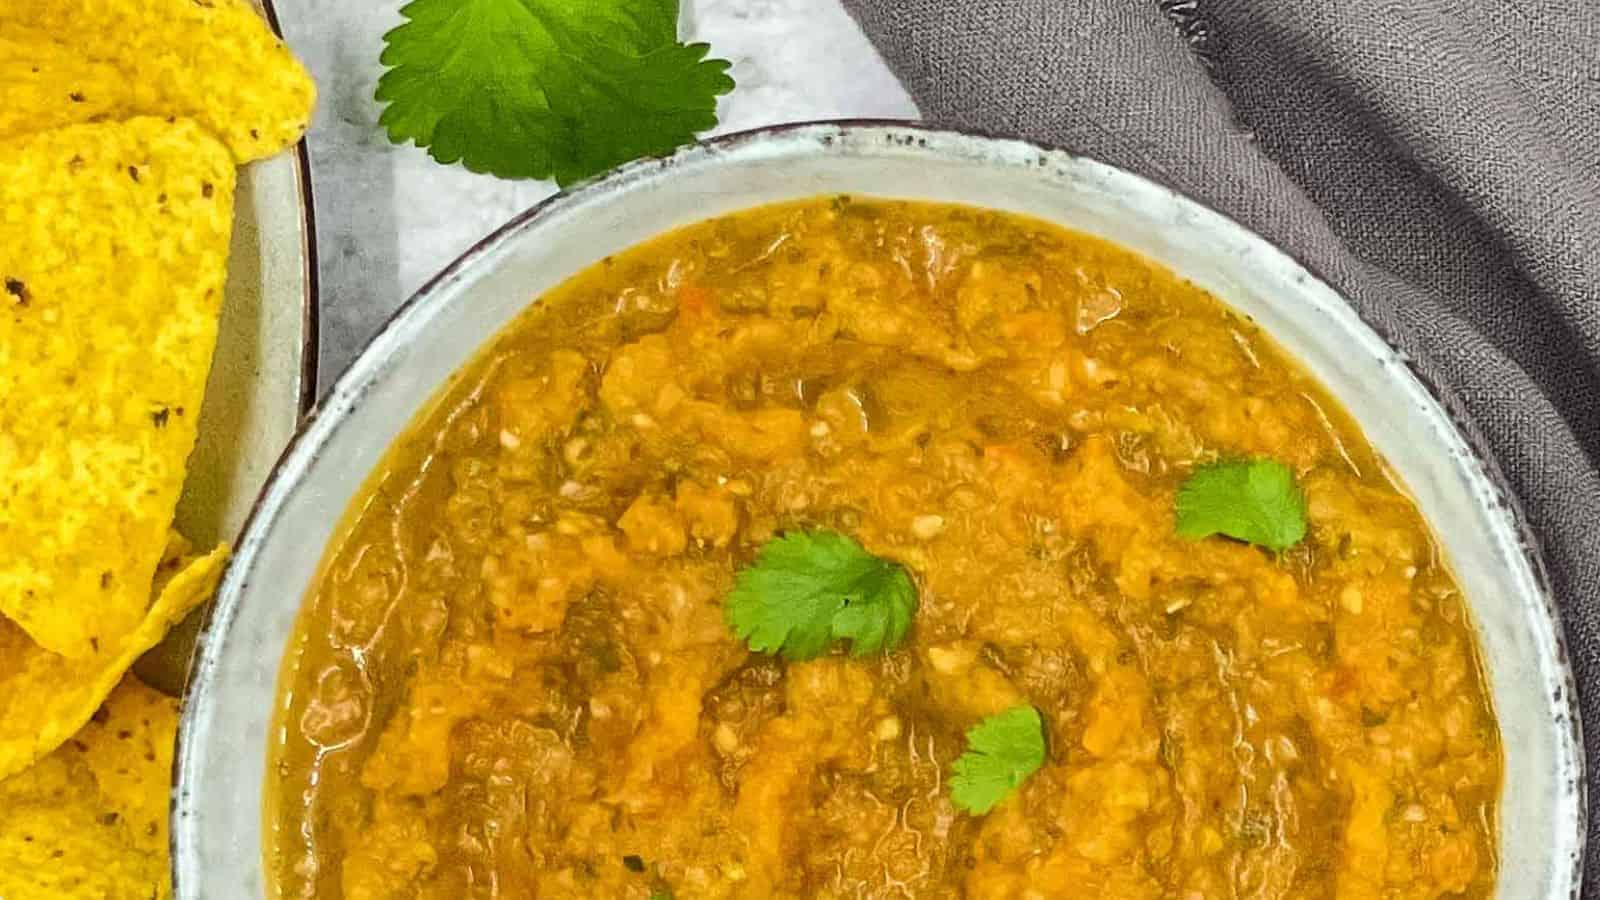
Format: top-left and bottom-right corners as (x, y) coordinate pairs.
(0, 0), (315, 883)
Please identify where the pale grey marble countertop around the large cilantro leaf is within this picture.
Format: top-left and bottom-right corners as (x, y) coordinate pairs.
(277, 0), (917, 389)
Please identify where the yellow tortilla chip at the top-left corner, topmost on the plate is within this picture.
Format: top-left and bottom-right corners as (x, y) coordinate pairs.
(0, 0), (315, 162)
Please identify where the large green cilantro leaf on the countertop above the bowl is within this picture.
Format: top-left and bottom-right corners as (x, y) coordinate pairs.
(378, 0), (733, 187)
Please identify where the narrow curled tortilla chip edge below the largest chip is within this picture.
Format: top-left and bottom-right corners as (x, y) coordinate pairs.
(0, 538), (227, 778)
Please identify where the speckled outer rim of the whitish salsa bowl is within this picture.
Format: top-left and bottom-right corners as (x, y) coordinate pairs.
(170, 115), (1589, 900)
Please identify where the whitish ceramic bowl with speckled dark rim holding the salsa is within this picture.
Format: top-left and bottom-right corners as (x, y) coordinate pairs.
(173, 123), (1584, 900)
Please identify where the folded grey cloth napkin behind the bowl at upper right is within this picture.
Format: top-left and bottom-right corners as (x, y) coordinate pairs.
(843, 0), (1600, 883)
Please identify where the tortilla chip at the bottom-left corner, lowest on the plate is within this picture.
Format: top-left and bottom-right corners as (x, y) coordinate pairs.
(0, 676), (178, 900)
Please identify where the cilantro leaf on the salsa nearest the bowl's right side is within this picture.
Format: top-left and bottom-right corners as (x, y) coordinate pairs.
(1178, 460), (1306, 552)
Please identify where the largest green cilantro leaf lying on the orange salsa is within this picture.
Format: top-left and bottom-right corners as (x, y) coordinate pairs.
(723, 532), (917, 660)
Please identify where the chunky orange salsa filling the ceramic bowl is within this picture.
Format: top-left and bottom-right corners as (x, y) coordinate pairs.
(267, 197), (1501, 900)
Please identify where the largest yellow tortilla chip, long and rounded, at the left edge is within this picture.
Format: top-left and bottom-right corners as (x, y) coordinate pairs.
(0, 115), (235, 657)
